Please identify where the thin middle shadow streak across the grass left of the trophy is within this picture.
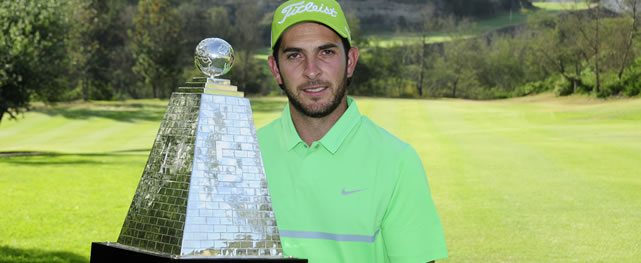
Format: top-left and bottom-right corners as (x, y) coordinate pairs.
(0, 148), (151, 165)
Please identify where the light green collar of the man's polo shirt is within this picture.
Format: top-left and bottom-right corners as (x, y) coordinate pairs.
(281, 96), (361, 154)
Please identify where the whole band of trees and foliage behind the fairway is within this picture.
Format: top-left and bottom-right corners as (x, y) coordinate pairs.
(0, 0), (641, 121)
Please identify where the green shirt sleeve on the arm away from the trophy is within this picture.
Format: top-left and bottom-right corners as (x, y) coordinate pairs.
(381, 146), (447, 263)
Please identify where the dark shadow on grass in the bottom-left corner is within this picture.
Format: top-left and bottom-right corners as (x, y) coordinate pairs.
(0, 246), (89, 263)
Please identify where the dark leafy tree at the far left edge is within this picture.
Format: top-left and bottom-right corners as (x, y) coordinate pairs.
(0, 0), (67, 124)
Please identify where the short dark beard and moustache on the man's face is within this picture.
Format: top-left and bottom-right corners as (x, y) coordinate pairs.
(281, 72), (347, 118)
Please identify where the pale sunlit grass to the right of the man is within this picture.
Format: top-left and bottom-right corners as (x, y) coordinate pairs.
(362, 94), (641, 262)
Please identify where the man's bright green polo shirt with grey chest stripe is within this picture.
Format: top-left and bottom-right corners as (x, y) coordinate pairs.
(258, 98), (447, 263)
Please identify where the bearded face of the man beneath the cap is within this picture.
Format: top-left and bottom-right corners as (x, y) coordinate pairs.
(269, 23), (358, 118)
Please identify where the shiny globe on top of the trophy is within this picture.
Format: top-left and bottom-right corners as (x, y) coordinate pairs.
(194, 38), (234, 78)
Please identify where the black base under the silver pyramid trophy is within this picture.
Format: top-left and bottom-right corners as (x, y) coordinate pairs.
(89, 242), (307, 263)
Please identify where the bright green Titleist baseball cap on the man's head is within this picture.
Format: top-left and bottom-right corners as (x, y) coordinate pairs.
(271, 0), (352, 49)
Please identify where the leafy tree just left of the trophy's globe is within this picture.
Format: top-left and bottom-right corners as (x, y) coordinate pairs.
(130, 0), (181, 98)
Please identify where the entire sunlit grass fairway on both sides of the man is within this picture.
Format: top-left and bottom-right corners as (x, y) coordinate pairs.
(0, 94), (641, 262)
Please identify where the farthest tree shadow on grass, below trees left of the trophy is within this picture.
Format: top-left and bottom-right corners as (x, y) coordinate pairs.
(33, 102), (167, 122)
